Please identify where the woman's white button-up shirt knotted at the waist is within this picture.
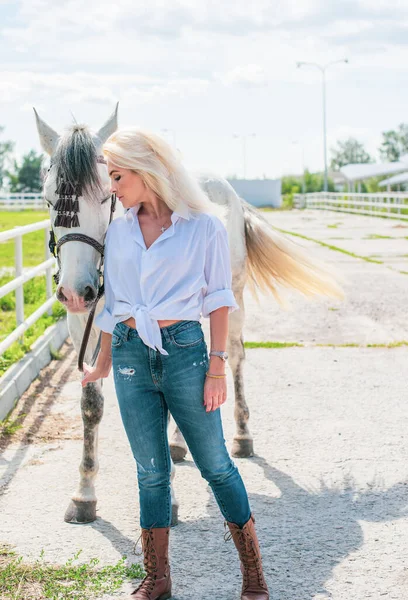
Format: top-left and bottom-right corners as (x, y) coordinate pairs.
(95, 204), (239, 354)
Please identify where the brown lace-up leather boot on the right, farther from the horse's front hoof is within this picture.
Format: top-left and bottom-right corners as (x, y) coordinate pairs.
(226, 515), (269, 600)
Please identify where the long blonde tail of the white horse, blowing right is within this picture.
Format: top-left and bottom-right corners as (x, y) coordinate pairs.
(241, 199), (344, 304)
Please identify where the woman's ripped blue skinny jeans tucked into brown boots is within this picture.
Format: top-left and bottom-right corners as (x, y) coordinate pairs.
(112, 321), (250, 529)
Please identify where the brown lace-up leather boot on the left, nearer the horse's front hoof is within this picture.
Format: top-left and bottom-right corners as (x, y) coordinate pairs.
(131, 527), (171, 600)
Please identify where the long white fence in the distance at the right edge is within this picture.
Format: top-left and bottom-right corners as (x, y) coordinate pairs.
(294, 192), (408, 220)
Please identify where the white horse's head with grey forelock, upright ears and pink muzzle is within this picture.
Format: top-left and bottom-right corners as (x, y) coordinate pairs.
(34, 105), (118, 313)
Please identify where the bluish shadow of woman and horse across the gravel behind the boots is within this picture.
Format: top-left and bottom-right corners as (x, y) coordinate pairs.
(85, 456), (408, 600)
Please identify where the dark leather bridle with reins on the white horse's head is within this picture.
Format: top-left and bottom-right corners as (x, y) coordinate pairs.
(48, 156), (116, 371)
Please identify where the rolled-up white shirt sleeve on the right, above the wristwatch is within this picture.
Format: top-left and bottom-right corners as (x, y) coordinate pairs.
(202, 225), (239, 317)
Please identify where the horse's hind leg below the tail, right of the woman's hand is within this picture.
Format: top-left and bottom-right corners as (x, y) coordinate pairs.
(227, 289), (254, 458)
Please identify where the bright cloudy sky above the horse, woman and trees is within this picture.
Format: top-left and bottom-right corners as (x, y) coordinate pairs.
(0, 0), (408, 178)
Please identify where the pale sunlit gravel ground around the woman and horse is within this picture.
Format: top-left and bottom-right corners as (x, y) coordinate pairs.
(0, 212), (408, 600)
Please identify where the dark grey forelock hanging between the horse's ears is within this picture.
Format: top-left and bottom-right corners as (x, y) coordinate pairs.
(52, 124), (101, 197)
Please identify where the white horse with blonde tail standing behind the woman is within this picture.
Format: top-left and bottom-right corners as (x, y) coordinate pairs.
(35, 106), (342, 524)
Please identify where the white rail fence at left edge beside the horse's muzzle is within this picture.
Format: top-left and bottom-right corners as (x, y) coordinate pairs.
(0, 219), (55, 356)
